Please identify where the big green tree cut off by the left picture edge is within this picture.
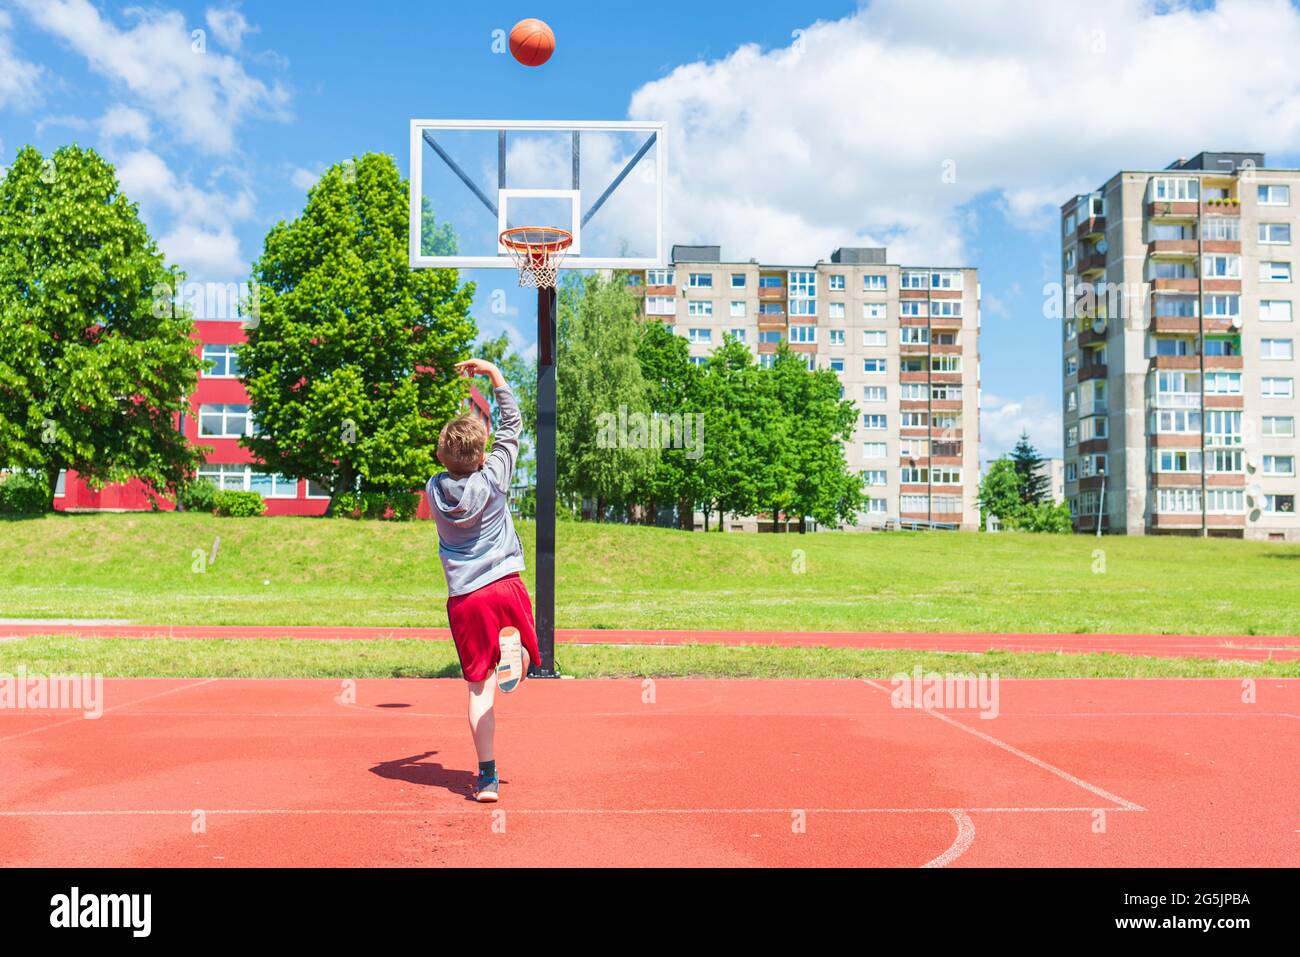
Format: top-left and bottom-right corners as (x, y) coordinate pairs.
(0, 146), (202, 509)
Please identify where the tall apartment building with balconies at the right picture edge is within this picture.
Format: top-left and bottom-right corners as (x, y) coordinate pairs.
(1061, 152), (1300, 541)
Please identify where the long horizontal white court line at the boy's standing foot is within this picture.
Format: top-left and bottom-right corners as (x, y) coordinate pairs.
(0, 804), (1141, 827)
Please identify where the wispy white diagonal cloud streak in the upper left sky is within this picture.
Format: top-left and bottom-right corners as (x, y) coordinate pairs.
(16, 0), (289, 153)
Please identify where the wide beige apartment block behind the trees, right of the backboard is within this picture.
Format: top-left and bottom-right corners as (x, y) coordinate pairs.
(631, 246), (980, 529)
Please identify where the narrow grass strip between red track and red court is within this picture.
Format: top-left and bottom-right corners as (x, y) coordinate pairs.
(0, 636), (1300, 679)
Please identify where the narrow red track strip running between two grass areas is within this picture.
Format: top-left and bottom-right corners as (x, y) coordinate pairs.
(0, 620), (1300, 661)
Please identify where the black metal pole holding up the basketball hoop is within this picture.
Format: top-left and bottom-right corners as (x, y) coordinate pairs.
(532, 287), (558, 677)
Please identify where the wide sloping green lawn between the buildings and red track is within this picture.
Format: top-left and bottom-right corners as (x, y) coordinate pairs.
(0, 514), (1300, 634)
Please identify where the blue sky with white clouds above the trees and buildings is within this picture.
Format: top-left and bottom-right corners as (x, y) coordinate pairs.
(0, 0), (1300, 458)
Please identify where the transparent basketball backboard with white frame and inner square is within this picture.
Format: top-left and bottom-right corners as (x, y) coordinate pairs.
(411, 120), (667, 269)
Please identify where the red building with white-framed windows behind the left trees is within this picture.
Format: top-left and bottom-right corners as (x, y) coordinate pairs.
(55, 320), (490, 519)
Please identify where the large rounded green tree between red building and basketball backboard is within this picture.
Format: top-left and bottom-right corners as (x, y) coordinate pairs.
(239, 153), (476, 512)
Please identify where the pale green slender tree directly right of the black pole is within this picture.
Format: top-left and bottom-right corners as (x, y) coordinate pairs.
(556, 274), (658, 521)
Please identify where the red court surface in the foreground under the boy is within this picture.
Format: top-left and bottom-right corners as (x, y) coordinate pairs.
(0, 679), (1300, 867)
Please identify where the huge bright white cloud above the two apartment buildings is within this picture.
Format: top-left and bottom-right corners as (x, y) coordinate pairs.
(628, 0), (1300, 265)
